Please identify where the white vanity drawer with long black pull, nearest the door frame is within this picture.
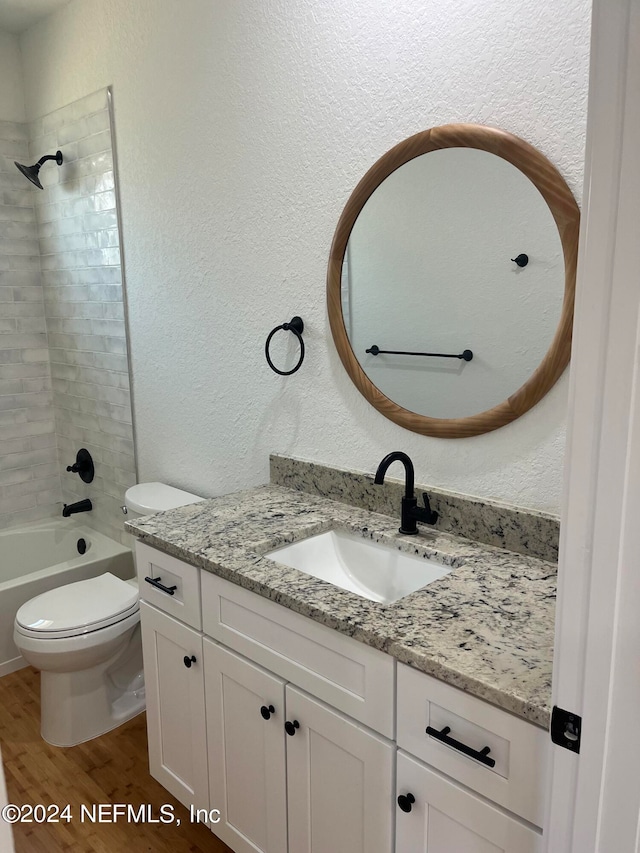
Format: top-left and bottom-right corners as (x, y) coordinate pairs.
(397, 664), (549, 826)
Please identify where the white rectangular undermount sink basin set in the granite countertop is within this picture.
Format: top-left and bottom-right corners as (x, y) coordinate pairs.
(264, 530), (453, 604)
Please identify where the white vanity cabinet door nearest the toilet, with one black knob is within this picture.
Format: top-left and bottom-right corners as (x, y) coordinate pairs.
(140, 602), (209, 809)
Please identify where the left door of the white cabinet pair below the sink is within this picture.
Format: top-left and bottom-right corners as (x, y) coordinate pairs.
(204, 639), (287, 853)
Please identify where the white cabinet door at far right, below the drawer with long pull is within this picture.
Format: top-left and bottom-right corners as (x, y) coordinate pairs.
(396, 751), (542, 853)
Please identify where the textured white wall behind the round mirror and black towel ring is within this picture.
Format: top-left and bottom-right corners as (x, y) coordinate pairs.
(21, 0), (590, 511)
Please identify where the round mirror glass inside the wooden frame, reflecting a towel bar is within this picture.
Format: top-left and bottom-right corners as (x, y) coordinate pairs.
(341, 148), (565, 418)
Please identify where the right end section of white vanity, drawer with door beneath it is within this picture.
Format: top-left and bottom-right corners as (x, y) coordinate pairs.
(396, 664), (548, 853)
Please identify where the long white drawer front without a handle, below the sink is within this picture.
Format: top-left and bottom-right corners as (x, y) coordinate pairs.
(201, 571), (395, 738)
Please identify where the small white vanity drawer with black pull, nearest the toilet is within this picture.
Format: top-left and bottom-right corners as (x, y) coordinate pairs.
(136, 542), (202, 631)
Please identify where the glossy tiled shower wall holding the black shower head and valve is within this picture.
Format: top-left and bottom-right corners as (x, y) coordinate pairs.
(0, 90), (135, 541)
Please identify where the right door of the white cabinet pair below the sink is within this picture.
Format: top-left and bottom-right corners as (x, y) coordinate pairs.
(286, 685), (396, 853)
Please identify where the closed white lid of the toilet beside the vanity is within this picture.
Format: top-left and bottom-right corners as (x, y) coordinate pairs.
(16, 572), (139, 637)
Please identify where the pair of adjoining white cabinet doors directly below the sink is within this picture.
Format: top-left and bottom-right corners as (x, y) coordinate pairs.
(204, 639), (395, 853)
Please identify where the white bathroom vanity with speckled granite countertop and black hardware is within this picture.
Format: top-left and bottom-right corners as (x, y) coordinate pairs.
(129, 485), (555, 853)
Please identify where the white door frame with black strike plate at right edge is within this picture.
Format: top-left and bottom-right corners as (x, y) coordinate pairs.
(545, 0), (640, 853)
